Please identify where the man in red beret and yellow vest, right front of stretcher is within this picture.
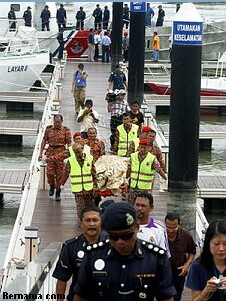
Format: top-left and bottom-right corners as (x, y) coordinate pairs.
(126, 139), (167, 203)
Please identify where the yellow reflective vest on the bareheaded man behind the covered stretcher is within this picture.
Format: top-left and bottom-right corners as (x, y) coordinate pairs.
(117, 124), (139, 157)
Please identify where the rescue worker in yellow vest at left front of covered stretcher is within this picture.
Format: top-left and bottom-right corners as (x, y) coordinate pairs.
(68, 143), (97, 218)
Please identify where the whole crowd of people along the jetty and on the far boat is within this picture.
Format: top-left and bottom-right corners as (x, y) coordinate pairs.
(19, 4), (222, 301)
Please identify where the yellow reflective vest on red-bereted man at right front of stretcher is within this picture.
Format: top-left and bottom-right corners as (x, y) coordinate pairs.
(130, 152), (155, 190)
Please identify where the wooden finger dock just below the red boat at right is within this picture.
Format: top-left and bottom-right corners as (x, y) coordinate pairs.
(144, 94), (226, 107)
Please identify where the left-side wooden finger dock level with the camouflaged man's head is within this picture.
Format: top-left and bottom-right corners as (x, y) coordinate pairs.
(0, 120), (40, 136)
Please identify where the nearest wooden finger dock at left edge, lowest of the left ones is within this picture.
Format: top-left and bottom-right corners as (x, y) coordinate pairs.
(0, 169), (27, 194)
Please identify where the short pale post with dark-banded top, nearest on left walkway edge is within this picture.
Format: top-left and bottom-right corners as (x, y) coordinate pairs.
(24, 226), (38, 264)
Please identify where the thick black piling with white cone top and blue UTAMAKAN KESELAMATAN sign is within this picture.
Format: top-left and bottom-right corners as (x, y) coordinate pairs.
(168, 3), (203, 235)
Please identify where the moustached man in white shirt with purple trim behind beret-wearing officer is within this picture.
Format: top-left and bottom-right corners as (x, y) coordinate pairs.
(134, 191), (170, 257)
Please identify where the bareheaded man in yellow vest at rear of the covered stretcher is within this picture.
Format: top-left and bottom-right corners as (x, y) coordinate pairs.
(113, 113), (139, 157)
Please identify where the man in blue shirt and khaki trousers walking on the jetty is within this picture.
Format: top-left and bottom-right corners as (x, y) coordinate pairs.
(71, 63), (88, 115)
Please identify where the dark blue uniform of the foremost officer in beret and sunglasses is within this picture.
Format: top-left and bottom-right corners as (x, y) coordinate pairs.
(75, 239), (176, 301)
